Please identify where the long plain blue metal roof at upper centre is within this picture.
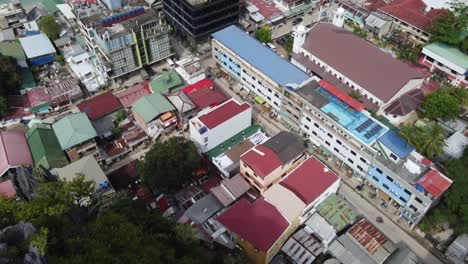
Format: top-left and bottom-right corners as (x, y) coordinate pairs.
(213, 26), (310, 86)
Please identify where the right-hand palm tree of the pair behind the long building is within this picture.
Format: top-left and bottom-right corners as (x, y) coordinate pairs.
(421, 124), (447, 159)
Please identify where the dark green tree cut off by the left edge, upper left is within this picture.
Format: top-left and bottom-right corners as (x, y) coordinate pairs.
(0, 54), (21, 96)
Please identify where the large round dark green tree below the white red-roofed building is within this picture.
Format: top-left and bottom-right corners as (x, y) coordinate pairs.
(139, 137), (200, 192)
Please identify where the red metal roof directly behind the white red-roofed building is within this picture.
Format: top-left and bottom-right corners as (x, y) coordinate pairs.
(182, 79), (228, 110)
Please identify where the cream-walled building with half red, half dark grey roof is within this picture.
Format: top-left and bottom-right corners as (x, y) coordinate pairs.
(240, 131), (307, 194)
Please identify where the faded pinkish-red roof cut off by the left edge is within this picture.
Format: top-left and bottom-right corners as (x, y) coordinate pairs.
(0, 131), (34, 176)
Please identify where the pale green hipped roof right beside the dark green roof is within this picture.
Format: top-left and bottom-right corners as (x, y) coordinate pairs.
(52, 113), (97, 150)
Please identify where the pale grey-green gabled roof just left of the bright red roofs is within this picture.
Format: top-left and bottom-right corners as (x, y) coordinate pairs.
(132, 93), (175, 123)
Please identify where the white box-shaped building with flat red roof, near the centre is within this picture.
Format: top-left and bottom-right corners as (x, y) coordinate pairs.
(189, 99), (252, 153)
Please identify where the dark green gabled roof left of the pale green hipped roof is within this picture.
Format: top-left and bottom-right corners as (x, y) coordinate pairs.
(26, 124), (68, 169)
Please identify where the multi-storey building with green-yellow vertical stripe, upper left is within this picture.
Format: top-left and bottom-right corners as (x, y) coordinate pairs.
(73, 5), (173, 78)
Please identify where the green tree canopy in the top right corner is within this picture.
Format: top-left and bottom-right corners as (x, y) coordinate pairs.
(431, 0), (468, 54)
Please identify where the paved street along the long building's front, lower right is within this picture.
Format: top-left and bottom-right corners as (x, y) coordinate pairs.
(338, 184), (442, 264)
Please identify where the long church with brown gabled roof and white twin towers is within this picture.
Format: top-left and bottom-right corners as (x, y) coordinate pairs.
(291, 23), (428, 124)
